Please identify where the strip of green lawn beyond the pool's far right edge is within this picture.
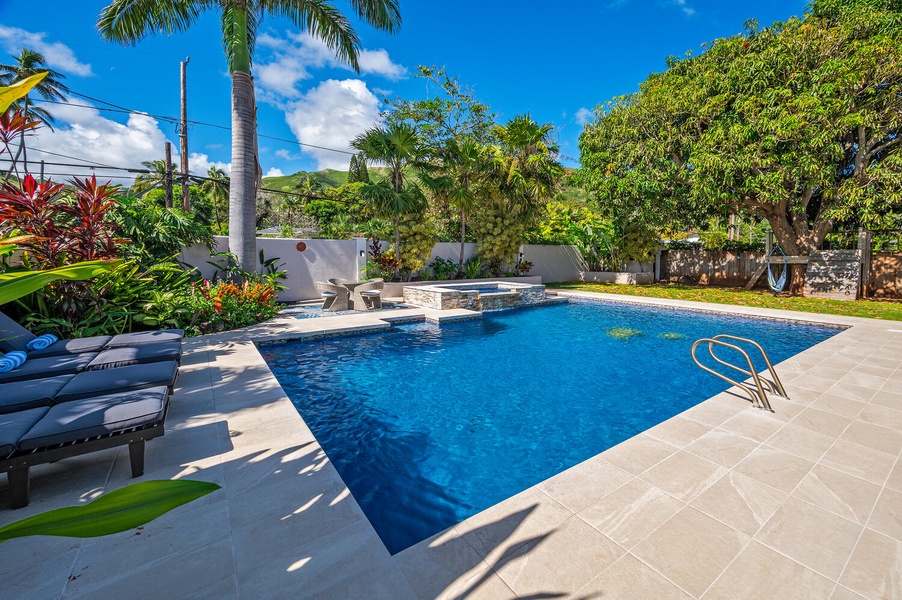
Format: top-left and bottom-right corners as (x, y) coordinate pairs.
(548, 282), (902, 321)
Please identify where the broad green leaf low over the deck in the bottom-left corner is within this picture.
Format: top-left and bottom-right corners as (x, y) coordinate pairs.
(0, 479), (219, 543)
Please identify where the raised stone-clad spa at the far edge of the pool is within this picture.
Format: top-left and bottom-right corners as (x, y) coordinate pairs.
(404, 281), (545, 311)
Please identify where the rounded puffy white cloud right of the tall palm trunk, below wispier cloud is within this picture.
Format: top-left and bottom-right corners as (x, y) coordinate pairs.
(285, 79), (379, 169)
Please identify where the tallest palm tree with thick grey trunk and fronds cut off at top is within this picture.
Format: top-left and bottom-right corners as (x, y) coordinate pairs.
(97, 0), (401, 270)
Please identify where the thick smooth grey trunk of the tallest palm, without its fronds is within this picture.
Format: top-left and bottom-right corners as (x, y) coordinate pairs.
(229, 70), (257, 271)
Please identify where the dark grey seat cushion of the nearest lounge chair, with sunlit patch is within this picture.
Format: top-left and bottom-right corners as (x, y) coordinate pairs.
(18, 386), (169, 450)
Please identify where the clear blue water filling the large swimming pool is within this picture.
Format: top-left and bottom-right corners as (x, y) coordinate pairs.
(260, 302), (839, 553)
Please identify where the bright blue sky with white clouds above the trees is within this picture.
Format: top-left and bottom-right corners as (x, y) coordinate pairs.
(0, 0), (806, 182)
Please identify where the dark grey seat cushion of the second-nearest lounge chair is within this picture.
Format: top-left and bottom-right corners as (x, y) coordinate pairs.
(53, 361), (178, 404)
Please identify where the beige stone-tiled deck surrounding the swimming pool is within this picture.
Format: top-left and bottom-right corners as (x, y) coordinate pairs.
(0, 292), (902, 600)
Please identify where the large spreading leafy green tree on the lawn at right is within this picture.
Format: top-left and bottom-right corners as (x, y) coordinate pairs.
(580, 0), (902, 292)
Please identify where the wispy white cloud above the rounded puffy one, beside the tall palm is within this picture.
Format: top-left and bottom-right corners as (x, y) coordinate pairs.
(254, 33), (407, 98)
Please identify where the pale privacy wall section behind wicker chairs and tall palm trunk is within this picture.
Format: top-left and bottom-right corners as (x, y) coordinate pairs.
(181, 236), (366, 302)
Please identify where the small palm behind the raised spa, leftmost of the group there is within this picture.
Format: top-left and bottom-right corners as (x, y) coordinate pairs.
(351, 123), (426, 278)
